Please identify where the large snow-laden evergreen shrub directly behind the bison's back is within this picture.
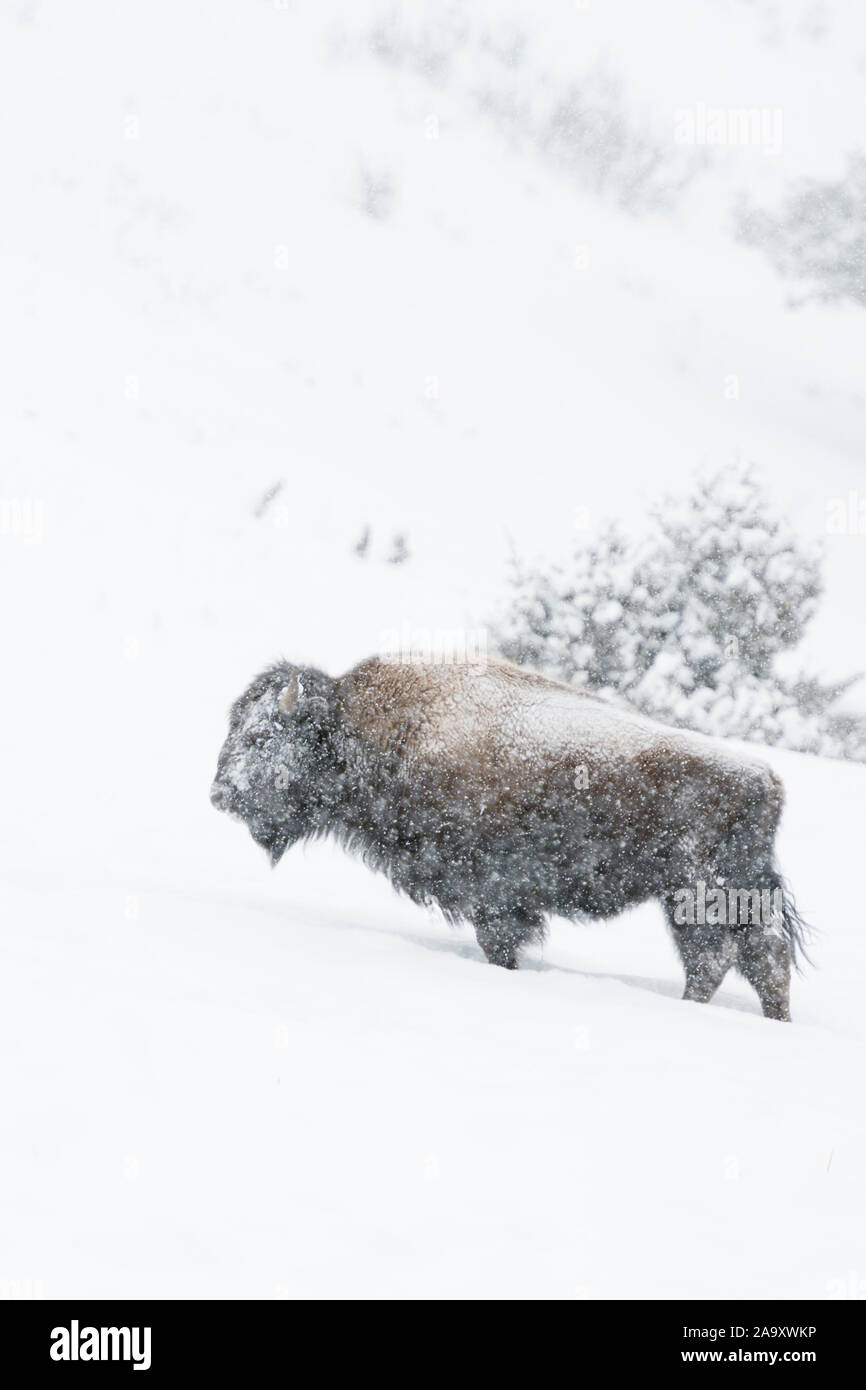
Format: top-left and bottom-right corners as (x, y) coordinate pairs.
(495, 467), (866, 760)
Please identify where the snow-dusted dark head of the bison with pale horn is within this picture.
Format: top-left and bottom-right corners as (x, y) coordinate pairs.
(210, 663), (334, 865)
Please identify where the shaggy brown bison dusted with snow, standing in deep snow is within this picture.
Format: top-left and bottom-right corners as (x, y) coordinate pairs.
(211, 657), (803, 1019)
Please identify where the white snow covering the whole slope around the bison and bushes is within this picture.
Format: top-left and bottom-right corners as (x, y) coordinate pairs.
(0, 0), (866, 1298)
